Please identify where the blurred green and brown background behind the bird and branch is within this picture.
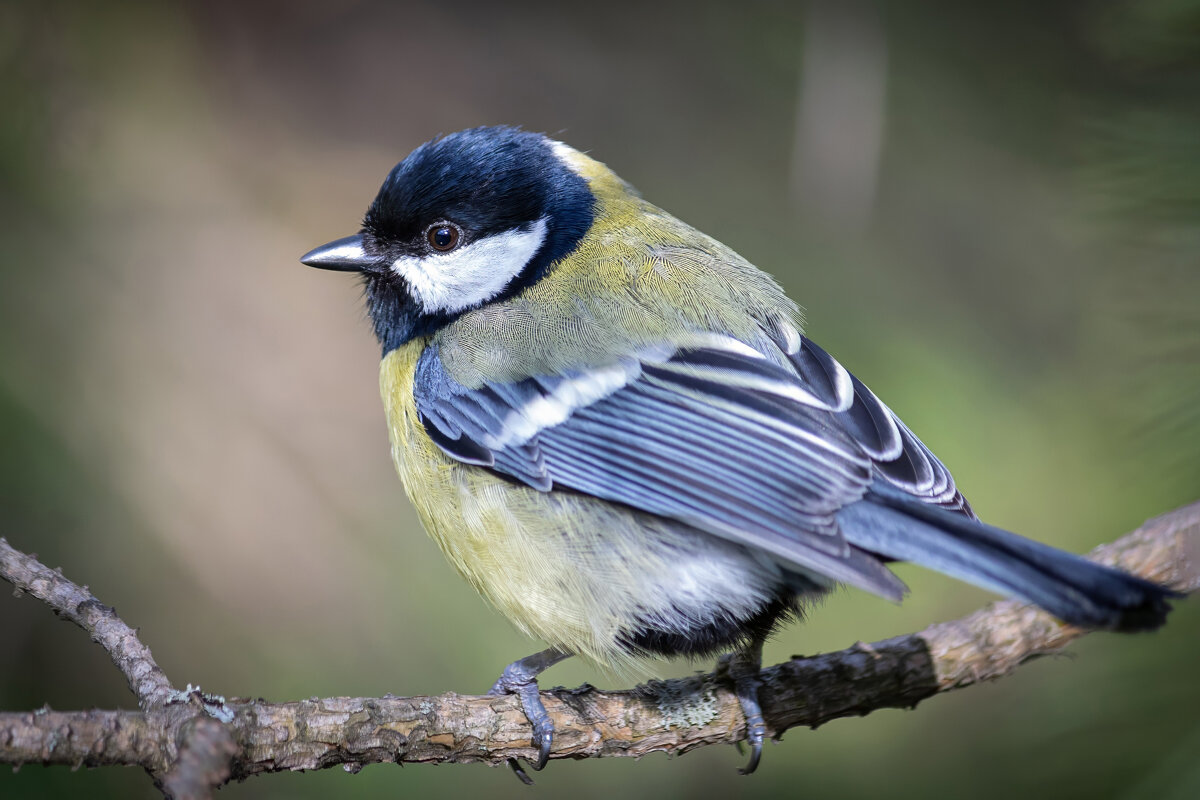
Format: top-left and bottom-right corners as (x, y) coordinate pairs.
(0, 0), (1200, 800)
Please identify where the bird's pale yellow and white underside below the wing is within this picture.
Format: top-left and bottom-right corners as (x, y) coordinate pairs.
(382, 348), (791, 669)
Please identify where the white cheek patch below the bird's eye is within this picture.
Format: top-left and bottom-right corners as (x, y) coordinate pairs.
(391, 218), (546, 313)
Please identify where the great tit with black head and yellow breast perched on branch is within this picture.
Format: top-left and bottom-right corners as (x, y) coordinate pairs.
(301, 127), (1171, 777)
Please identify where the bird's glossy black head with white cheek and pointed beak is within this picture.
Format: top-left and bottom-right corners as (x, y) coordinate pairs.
(300, 127), (595, 353)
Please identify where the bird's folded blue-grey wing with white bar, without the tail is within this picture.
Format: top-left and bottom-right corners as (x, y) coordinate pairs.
(414, 331), (961, 597)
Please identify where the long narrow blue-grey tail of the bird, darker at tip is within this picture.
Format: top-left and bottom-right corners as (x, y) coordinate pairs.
(838, 487), (1182, 632)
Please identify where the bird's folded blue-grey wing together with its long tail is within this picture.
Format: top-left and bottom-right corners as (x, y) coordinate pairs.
(414, 326), (1160, 638)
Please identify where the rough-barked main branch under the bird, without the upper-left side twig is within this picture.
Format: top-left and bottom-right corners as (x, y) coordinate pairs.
(0, 503), (1200, 796)
